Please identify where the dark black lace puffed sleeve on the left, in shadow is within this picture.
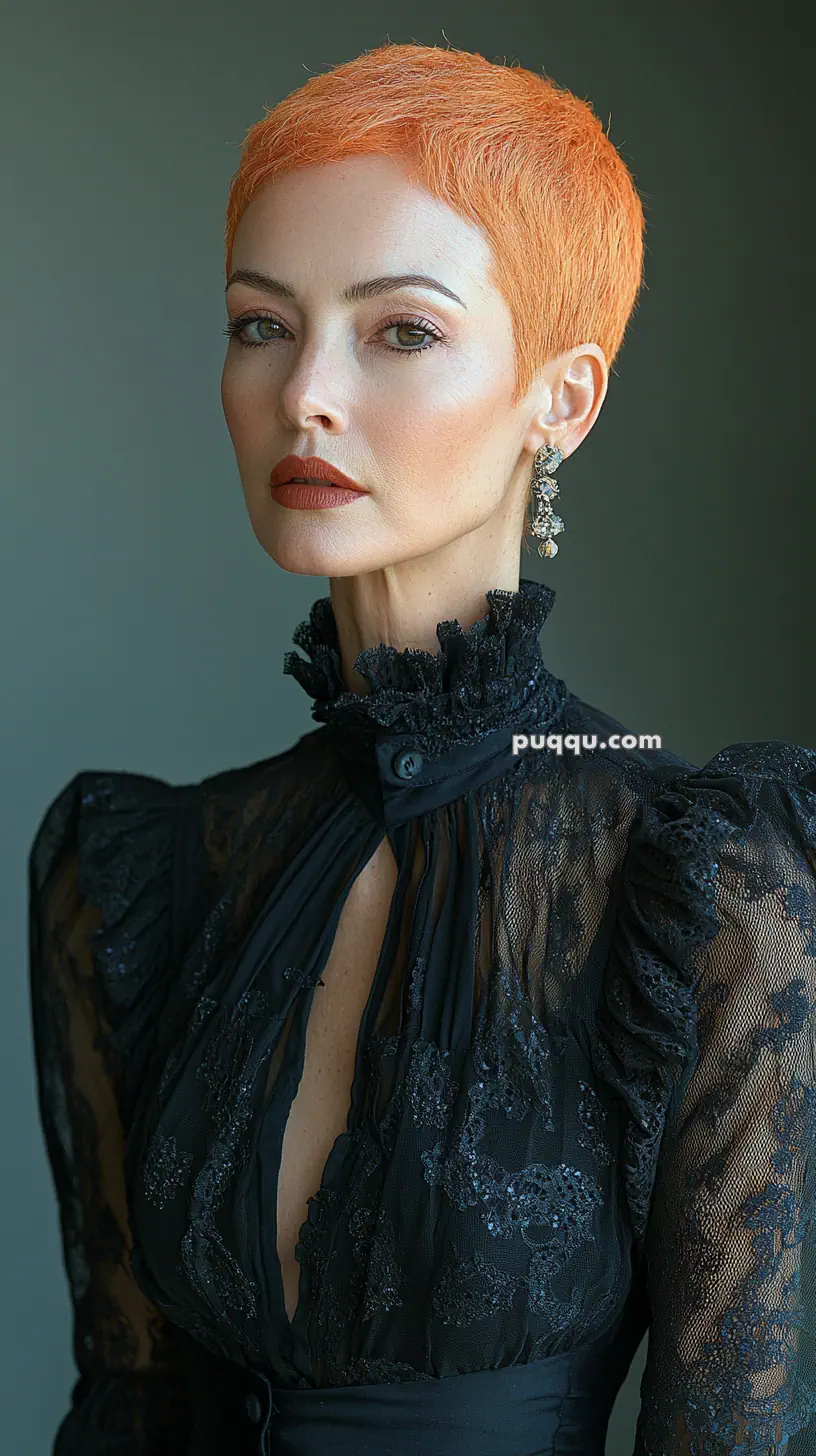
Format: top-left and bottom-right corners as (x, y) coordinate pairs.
(29, 772), (198, 1456)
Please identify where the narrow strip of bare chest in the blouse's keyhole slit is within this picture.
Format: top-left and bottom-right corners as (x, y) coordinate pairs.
(277, 840), (396, 1321)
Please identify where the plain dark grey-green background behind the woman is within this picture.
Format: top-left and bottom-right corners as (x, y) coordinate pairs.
(0, 0), (816, 1456)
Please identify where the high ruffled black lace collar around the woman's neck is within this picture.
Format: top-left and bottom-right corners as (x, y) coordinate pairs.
(283, 577), (567, 754)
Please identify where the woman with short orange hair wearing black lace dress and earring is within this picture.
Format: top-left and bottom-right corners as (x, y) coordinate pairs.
(31, 45), (816, 1456)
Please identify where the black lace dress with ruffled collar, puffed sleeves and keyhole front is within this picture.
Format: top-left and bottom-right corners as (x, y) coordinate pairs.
(29, 578), (816, 1456)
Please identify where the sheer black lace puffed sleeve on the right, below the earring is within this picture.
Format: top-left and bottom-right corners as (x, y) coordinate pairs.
(602, 741), (816, 1456)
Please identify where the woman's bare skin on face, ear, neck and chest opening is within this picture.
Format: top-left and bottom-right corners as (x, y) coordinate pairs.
(221, 156), (608, 1319)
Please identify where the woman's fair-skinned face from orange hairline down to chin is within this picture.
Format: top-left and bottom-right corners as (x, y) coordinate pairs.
(221, 156), (603, 577)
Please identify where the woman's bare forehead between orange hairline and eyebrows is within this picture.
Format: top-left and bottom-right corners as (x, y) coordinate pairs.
(232, 156), (493, 298)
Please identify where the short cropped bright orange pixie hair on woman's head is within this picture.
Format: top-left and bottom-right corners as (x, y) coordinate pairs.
(224, 44), (644, 405)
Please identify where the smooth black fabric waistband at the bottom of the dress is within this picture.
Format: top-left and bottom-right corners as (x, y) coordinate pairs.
(177, 1292), (637, 1456)
